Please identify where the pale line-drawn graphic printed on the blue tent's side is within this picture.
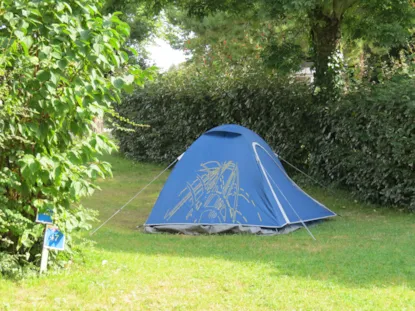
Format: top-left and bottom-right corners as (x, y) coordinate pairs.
(164, 161), (262, 224)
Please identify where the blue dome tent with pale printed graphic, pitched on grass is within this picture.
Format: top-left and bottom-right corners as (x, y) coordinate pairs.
(144, 125), (336, 234)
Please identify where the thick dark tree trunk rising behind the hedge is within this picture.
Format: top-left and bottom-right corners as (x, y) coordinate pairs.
(310, 8), (341, 105)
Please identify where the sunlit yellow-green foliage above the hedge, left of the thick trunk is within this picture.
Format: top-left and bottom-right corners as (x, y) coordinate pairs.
(166, 8), (308, 73)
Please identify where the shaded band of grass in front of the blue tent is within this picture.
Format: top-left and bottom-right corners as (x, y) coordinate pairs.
(94, 218), (415, 289)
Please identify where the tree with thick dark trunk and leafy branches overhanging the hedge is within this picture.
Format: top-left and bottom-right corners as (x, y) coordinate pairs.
(162, 0), (415, 104)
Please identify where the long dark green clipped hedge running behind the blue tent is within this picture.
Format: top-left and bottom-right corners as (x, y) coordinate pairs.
(115, 72), (415, 210)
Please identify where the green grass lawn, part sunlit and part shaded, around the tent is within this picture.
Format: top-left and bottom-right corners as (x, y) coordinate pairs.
(0, 156), (415, 310)
